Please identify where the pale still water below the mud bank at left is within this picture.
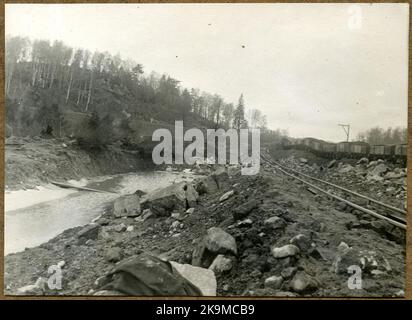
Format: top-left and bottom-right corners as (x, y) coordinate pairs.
(4, 171), (193, 254)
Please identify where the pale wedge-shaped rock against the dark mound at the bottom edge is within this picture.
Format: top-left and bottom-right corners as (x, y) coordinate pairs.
(170, 261), (217, 296)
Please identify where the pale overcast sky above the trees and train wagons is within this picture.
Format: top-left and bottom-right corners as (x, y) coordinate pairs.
(5, 4), (409, 141)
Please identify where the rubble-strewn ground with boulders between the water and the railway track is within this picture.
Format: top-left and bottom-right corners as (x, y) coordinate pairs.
(5, 160), (405, 297)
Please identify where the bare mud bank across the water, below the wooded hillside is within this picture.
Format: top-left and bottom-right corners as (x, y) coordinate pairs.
(5, 137), (153, 190)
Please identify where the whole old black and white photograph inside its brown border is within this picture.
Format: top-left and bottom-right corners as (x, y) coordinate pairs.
(4, 3), (409, 298)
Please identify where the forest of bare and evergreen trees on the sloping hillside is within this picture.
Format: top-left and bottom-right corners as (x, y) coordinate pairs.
(5, 36), (274, 148)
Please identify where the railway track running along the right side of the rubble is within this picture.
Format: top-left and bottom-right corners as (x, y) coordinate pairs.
(261, 155), (406, 230)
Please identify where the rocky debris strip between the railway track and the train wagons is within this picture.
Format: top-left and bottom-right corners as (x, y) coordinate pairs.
(280, 155), (407, 210)
